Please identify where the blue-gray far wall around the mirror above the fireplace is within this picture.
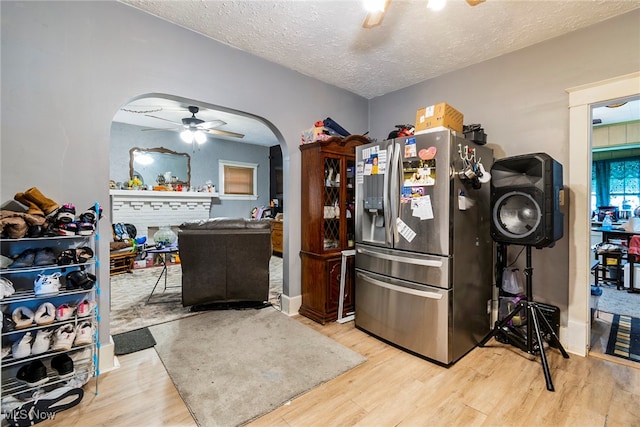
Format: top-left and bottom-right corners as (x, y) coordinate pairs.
(109, 122), (269, 219)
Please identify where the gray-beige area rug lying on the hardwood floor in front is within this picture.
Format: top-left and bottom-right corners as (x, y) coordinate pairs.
(149, 307), (366, 427)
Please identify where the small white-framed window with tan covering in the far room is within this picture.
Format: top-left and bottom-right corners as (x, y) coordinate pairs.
(218, 160), (258, 200)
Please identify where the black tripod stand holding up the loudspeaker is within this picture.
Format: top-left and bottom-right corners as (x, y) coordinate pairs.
(479, 246), (569, 391)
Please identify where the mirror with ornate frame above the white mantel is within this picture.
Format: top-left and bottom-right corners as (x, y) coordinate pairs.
(129, 147), (191, 187)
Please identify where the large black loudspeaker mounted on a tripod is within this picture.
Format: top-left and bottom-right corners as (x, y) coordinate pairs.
(490, 153), (563, 248)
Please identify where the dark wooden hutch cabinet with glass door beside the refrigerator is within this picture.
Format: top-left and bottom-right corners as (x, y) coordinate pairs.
(299, 135), (369, 324)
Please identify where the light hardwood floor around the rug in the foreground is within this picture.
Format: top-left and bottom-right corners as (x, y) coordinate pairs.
(40, 316), (640, 427)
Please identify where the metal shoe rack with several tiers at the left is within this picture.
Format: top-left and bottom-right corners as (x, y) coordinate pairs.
(0, 203), (100, 425)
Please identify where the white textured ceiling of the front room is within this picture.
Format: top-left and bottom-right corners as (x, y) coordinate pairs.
(121, 0), (640, 99)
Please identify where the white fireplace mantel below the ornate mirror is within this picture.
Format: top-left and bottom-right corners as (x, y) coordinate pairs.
(109, 190), (218, 235)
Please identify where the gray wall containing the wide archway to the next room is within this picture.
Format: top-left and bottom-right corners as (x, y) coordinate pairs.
(0, 1), (368, 337)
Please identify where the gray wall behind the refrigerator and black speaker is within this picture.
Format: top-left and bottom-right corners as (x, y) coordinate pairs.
(369, 10), (640, 323)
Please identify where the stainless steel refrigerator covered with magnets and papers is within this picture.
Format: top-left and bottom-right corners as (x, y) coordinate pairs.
(355, 128), (493, 365)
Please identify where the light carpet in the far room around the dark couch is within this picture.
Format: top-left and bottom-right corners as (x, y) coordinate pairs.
(109, 256), (282, 335)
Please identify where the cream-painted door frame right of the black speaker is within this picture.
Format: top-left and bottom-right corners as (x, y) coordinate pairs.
(561, 72), (640, 356)
